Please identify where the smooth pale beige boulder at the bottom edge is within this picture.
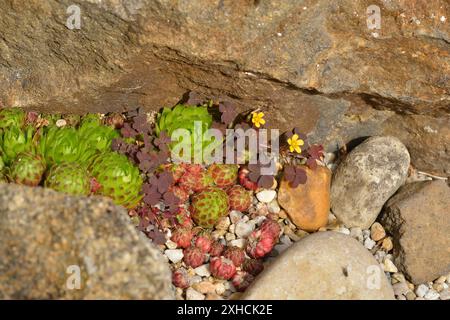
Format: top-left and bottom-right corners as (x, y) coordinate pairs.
(243, 231), (394, 300)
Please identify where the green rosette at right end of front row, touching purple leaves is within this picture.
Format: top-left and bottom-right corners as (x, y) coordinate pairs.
(89, 152), (143, 209)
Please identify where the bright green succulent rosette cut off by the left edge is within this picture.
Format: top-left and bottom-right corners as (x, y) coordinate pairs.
(0, 126), (36, 165)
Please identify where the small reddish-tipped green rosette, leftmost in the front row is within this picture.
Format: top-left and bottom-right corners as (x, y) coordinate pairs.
(9, 152), (46, 187)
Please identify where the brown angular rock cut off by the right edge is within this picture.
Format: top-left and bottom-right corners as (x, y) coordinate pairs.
(381, 181), (450, 284)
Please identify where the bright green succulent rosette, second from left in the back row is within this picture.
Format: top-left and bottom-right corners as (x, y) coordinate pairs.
(39, 127), (86, 165)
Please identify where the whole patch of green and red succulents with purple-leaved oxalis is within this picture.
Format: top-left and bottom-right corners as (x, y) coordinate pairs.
(0, 94), (323, 298)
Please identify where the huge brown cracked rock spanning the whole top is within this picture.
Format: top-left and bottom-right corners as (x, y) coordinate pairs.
(0, 0), (450, 175)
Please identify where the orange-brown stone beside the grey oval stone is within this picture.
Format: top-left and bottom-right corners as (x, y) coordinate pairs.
(278, 166), (331, 231)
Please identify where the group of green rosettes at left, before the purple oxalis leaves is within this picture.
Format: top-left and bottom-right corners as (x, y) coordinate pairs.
(0, 108), (142, 208)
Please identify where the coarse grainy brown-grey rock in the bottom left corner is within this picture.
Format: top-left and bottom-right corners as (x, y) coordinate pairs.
(0, 184), (174, 299)
